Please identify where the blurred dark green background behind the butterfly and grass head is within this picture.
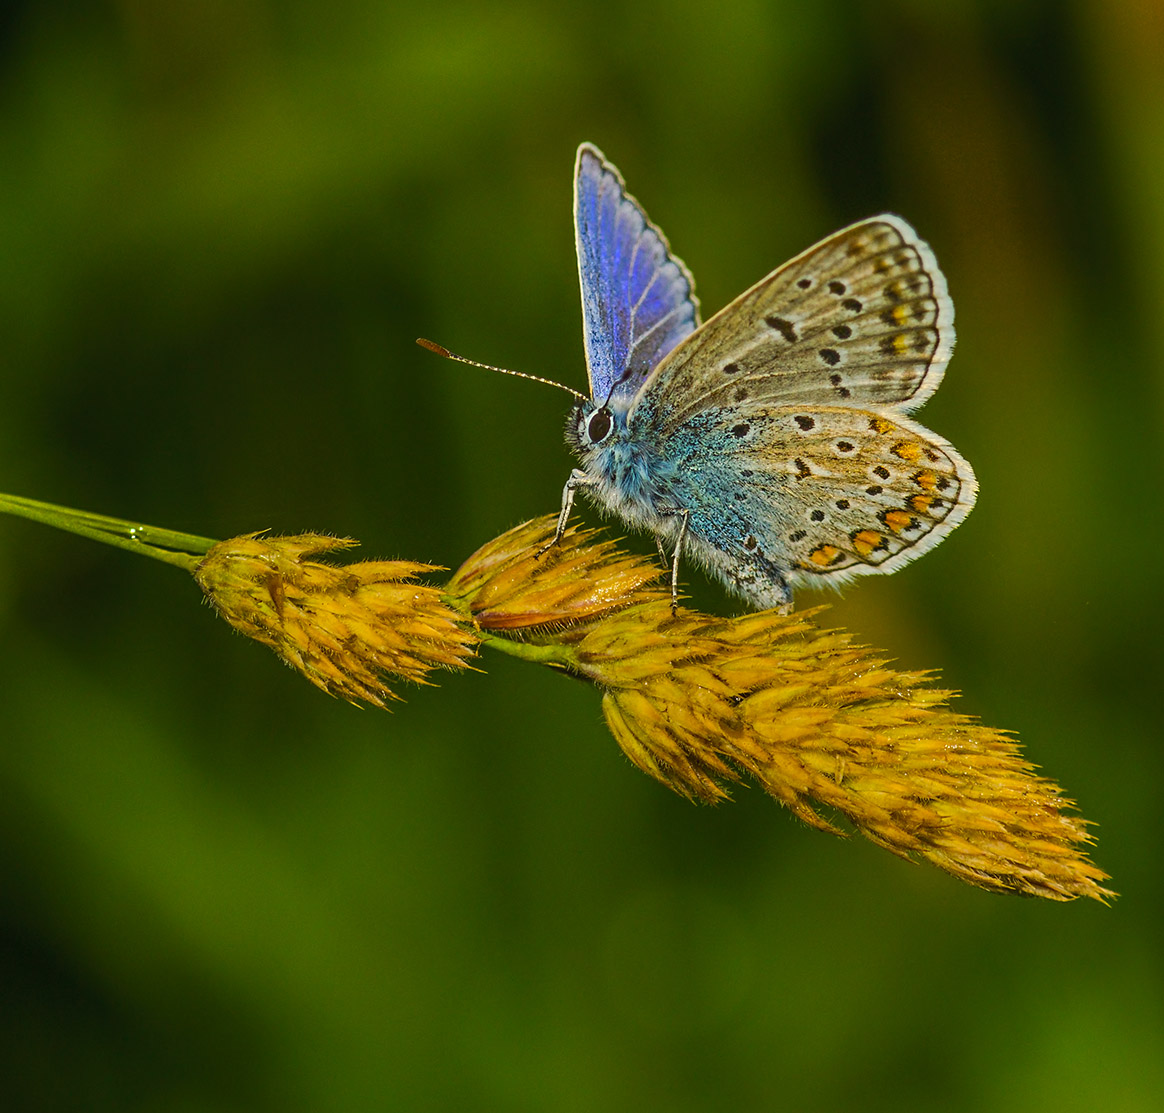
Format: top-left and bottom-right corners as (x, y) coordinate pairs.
(0, 0), (1164, 1113)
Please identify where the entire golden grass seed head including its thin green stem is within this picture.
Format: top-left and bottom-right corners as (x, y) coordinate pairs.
(0, 495), (1114, 901)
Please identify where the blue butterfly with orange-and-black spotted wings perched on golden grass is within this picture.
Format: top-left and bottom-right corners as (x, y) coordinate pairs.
(425, 143), (978, 611)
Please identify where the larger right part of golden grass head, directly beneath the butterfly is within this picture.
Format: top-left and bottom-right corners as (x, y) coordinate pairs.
(448, 518), (1114, 901)
